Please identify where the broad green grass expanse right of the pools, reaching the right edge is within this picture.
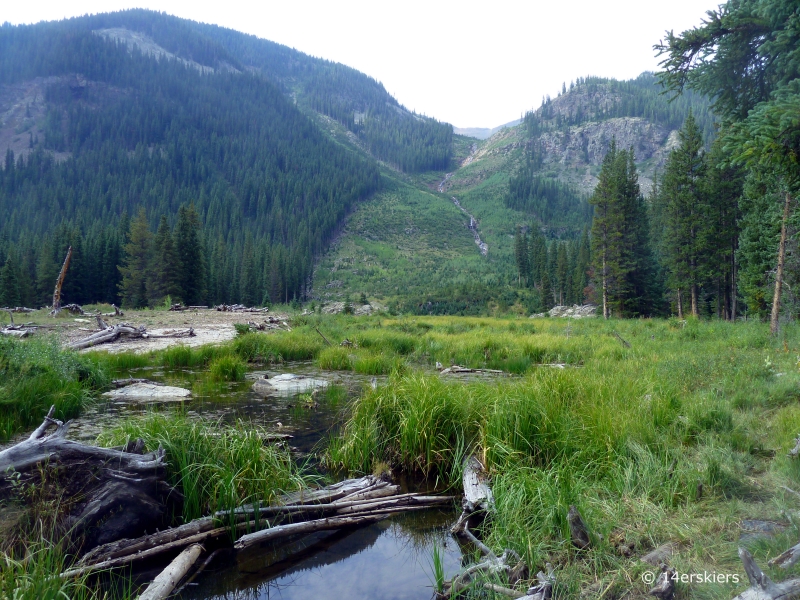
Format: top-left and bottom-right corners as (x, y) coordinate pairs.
(326, 318), (800, 598)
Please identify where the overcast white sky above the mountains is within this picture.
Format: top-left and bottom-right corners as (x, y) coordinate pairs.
(0, 0), (722, 127)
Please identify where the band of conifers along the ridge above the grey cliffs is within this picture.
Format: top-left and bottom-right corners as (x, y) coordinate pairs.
(523, 73), (715, 139)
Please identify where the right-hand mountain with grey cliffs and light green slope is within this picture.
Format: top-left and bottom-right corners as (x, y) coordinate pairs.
(313, 73), (714, 314)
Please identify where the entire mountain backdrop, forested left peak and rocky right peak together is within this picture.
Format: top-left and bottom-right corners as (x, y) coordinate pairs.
(0, 10), (713, 313)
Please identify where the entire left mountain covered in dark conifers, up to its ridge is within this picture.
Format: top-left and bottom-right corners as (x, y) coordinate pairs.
(0, 10), (452, 304)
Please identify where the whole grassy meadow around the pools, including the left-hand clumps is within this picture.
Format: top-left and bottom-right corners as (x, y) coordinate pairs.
(0, 314), (800, 599)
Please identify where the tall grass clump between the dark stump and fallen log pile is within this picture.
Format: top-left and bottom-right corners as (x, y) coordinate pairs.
(98, 412), (307, 521)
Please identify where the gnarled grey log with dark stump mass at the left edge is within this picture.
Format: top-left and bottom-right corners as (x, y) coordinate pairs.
(0, 407), (182, 549)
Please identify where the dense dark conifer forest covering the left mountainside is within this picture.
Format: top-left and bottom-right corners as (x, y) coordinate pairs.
(0, 14), (388, 304)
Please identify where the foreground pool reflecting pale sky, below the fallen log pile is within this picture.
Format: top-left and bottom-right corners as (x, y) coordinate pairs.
(181, 510), (461, 600)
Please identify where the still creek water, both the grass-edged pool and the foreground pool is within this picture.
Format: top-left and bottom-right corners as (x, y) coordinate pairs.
(70, 362), (462, 600)
